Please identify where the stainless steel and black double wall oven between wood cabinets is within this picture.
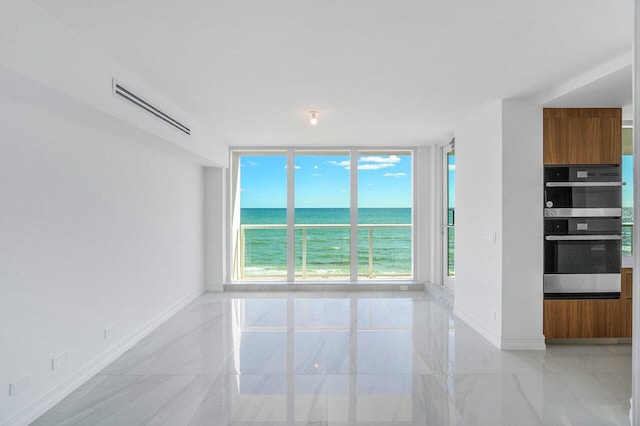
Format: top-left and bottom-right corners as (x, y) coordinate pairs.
(544, 165), (622, 299)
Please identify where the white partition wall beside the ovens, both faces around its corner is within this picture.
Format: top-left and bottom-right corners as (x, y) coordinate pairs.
(454, 99), (545, 349)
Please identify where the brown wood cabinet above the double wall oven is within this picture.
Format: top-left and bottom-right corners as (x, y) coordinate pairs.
(543, 108), (622, 164)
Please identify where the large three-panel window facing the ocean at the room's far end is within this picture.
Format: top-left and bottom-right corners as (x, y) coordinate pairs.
(231, 149), (414, 282)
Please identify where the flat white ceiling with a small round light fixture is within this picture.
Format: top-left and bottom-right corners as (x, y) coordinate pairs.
(32, 0), (633, 146)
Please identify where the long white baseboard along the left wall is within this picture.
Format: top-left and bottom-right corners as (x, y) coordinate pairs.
(0, 288), (204, 426)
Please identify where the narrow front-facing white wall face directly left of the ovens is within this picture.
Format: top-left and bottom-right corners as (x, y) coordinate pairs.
(501, 100), (544, 349)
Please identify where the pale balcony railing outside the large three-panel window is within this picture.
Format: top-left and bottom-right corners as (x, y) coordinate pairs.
(234, 224), (412, 280)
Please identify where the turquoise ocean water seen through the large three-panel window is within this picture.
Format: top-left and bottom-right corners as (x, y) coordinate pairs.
(240, 208), (412, 279)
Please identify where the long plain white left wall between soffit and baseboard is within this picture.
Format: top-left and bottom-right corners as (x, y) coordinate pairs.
(0, 96), (204, 424)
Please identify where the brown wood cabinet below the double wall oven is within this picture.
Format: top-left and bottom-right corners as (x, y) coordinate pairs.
(543, 268), (633, 339)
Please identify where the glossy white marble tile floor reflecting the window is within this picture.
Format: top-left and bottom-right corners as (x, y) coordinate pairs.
(33, 292), (631, 426)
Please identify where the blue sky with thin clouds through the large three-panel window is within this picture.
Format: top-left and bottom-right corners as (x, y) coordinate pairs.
(240, 153), (412, 208)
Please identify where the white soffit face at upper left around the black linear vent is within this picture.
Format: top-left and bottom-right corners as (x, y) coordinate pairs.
(0, 0), (228, 167)
